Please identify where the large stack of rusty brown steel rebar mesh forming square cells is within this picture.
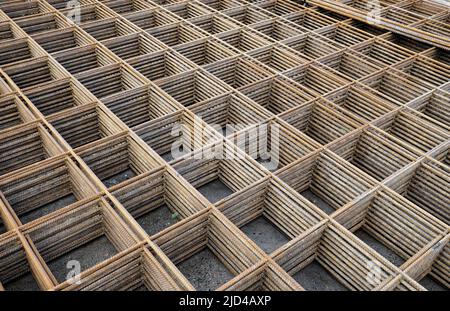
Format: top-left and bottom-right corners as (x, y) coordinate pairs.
(0, 0), (450, 290)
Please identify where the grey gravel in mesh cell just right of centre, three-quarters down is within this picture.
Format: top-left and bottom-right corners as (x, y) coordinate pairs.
(241, 216), (289, 254)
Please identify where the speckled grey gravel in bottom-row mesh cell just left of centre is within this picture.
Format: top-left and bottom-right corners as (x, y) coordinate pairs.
(177, 248), (234, 291)
